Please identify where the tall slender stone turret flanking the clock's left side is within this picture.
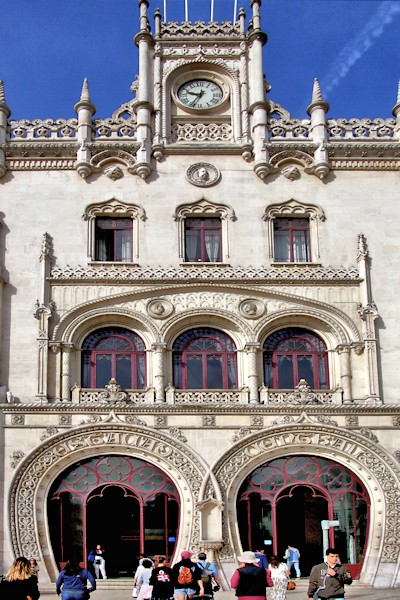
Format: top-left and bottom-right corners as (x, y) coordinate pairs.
(135, 0), (154, 179)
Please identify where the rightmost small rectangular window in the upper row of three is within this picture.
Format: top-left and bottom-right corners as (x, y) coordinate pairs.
(274, 219), (311, 263)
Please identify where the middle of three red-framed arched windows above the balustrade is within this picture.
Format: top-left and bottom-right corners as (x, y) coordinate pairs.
(173, 327), (237, 389)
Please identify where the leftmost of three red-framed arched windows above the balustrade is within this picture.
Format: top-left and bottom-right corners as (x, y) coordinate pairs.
(82, 327), (146, 389)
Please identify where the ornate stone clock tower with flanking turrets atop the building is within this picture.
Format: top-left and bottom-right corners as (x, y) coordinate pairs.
(135, 0), (270, 179)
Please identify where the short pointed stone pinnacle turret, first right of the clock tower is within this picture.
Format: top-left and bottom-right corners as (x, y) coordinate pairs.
(307, 78), (329, 179)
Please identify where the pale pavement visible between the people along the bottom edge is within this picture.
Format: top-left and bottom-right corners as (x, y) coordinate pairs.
(39, 579), (400, 600)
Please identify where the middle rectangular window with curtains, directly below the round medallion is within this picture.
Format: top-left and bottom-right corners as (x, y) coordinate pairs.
(185, 218), (222, 262)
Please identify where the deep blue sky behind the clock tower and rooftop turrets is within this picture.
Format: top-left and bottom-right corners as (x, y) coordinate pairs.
(0, 0), (400, 119)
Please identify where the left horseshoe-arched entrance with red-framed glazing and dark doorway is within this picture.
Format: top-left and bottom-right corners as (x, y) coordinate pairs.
(47, 455), (179, 577)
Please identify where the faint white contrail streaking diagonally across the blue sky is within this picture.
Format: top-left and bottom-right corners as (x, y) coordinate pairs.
(321, 0), (400, 96)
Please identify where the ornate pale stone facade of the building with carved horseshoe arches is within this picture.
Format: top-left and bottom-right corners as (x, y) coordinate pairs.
(0, 0), (400, 588)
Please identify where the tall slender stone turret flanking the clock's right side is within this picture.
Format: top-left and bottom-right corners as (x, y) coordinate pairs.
(249, 0), (271, 179)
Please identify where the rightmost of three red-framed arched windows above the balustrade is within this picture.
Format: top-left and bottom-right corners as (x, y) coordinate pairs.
(264, 327), (329, 389)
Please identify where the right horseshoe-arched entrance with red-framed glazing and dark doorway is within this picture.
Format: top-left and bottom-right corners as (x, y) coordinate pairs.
(237, 456), (369, 576)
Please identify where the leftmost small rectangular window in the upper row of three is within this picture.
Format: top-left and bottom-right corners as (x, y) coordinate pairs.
(96, 218), (133, 262)
